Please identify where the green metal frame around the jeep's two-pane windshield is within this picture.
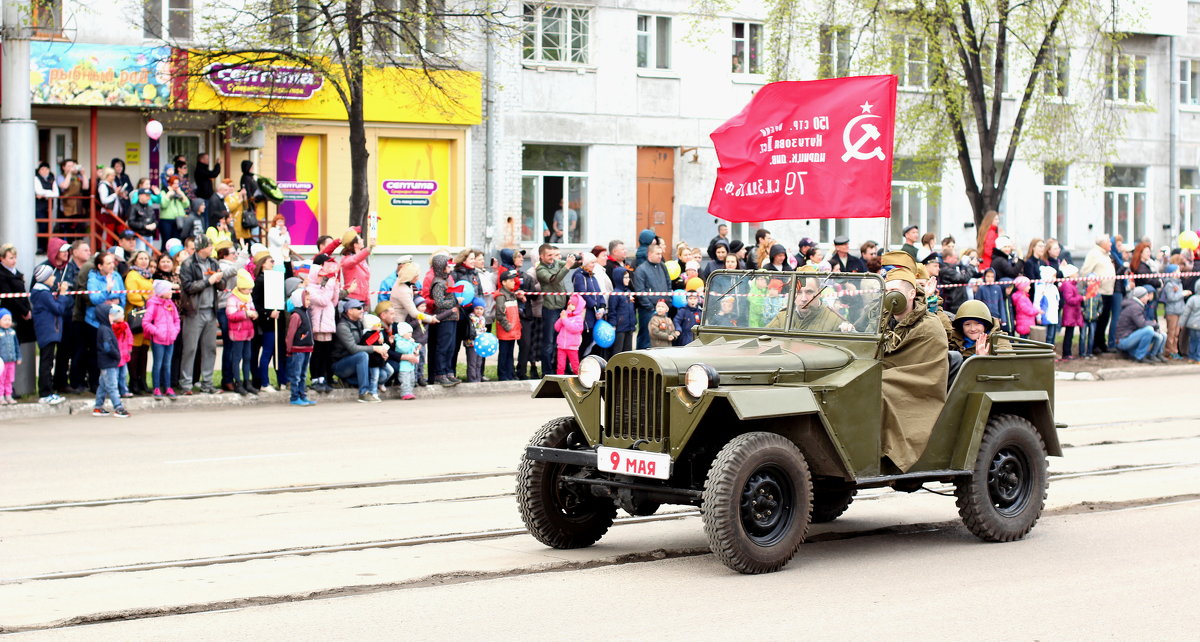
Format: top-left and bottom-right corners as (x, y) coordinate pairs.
(697, 269), (887, 341)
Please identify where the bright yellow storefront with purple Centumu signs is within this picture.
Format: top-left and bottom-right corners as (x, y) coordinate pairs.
(187, 56), (481, 249)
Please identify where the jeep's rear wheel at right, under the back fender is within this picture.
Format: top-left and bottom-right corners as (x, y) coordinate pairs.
(954, 415), (1049, 541)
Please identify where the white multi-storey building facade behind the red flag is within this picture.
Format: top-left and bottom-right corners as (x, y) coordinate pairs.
(472, 0), (1200, 261)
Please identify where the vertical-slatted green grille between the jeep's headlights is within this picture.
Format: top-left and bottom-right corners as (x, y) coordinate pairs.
(604, 366), (666, 444)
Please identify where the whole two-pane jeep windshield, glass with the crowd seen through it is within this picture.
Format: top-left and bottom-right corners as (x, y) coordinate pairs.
(703, 271), (884, 335)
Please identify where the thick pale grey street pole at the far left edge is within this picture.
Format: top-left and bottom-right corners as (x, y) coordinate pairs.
(0, 0), (37, 277)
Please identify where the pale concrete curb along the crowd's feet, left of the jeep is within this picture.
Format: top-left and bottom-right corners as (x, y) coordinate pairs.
(0, 380), (538, 421)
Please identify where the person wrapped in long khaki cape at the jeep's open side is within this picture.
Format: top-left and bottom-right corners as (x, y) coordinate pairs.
(882, 268), (949, 473)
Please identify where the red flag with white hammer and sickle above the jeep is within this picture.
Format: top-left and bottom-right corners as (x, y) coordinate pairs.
(708, 76), (896, 222)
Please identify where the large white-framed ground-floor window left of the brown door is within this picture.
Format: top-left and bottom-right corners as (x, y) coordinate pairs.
(521, 144), (588, 245)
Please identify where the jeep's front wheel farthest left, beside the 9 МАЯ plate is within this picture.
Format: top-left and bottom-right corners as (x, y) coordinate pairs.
(517, 416), (617, 548)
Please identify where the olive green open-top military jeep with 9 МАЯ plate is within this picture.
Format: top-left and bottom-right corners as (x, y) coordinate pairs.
(517, 270), (1062, 574)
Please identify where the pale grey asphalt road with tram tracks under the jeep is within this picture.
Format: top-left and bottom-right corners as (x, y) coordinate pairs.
(0, 376), (1200, 640)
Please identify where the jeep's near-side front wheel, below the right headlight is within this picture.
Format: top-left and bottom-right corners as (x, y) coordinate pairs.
(701, 432), (812, 574)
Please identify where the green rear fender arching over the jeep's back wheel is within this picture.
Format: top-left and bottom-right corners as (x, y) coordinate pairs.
(950, 390), (1062, 470)
